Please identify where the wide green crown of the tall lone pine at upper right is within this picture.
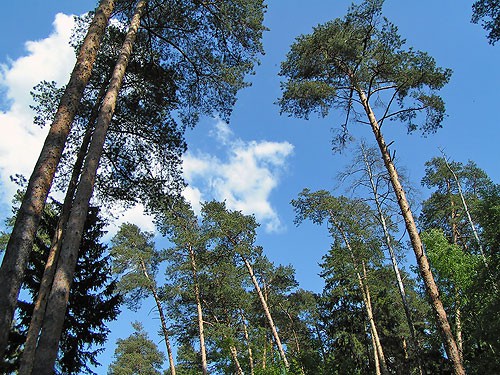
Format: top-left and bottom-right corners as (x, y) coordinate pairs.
(278, 0), (451, 141)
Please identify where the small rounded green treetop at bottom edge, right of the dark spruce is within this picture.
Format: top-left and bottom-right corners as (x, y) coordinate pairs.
(108, 322), (165, 375)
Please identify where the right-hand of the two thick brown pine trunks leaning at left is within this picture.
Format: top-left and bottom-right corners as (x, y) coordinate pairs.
(33, 0), (147, 375)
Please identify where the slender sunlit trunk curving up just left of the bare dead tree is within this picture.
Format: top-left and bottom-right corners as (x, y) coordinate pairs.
(328, 211), (388, 374)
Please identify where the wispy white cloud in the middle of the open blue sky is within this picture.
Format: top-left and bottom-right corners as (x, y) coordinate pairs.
(184, 120), (293, 232)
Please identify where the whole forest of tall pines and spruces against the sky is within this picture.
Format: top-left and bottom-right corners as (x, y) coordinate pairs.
(0, 0), (500, 375)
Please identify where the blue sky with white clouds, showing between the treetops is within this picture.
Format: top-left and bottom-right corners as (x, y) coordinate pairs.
(0, 0), (500, 374)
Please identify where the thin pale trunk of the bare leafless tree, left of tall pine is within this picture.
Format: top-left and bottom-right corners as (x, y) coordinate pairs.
(361, 146), (424, 374)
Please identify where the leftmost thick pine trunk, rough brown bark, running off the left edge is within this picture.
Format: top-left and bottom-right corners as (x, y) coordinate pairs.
(0, 0), (115, 358)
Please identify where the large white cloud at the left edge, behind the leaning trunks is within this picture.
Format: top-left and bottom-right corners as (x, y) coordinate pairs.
(0, 14), (75, 204)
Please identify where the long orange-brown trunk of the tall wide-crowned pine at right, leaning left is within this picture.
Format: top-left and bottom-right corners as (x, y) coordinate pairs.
(357, 88), (465, 375)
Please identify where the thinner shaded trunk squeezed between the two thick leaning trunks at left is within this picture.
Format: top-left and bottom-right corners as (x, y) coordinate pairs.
(19, 76), (108, 375)
